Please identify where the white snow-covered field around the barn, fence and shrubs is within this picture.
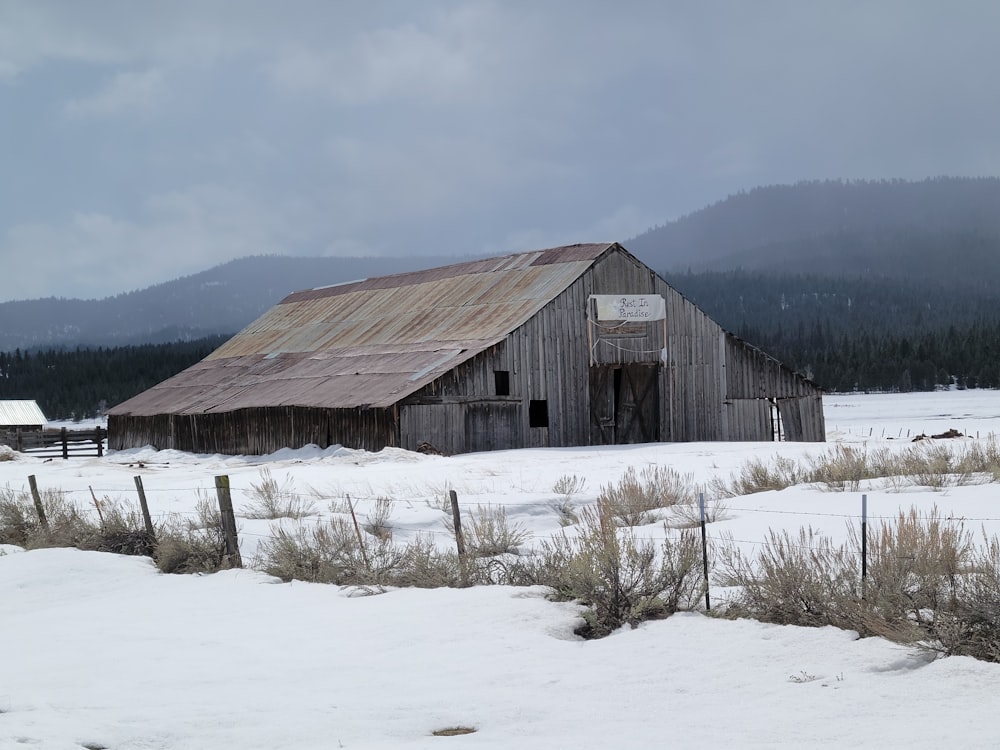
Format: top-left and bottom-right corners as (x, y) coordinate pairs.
(0, 391), (1000, 750)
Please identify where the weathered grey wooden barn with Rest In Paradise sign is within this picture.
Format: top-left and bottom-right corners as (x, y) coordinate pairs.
(108, 244), (825, 454)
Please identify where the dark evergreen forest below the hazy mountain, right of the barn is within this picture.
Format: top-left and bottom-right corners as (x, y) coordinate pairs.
(669, 271), (1000, 391)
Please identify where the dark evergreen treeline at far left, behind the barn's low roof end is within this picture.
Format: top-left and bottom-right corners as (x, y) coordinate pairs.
(0, 336), (228, 419)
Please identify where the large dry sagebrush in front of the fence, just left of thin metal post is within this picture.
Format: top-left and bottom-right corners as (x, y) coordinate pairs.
(533, 500), (704, 638)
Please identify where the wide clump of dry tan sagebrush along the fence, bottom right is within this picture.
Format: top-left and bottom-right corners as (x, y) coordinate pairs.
(716, 508), (1000, 661)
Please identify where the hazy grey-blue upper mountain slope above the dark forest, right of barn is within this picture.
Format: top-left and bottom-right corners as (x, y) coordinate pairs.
(626, 177), (1000, 275)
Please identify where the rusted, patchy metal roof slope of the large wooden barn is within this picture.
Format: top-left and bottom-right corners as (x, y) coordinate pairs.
(109, 244), (617, 416)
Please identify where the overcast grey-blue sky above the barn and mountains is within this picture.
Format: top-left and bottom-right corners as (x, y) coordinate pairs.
(0, 0), (1000, 302)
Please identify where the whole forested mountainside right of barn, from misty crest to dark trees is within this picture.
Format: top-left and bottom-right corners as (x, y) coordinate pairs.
(627, 177), (1000, 391)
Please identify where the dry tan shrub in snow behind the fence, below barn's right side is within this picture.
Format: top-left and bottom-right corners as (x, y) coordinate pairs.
(598, 466), (695, 526)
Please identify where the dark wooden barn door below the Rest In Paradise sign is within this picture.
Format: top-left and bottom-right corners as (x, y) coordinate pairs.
(590, 365), (660, 445)
